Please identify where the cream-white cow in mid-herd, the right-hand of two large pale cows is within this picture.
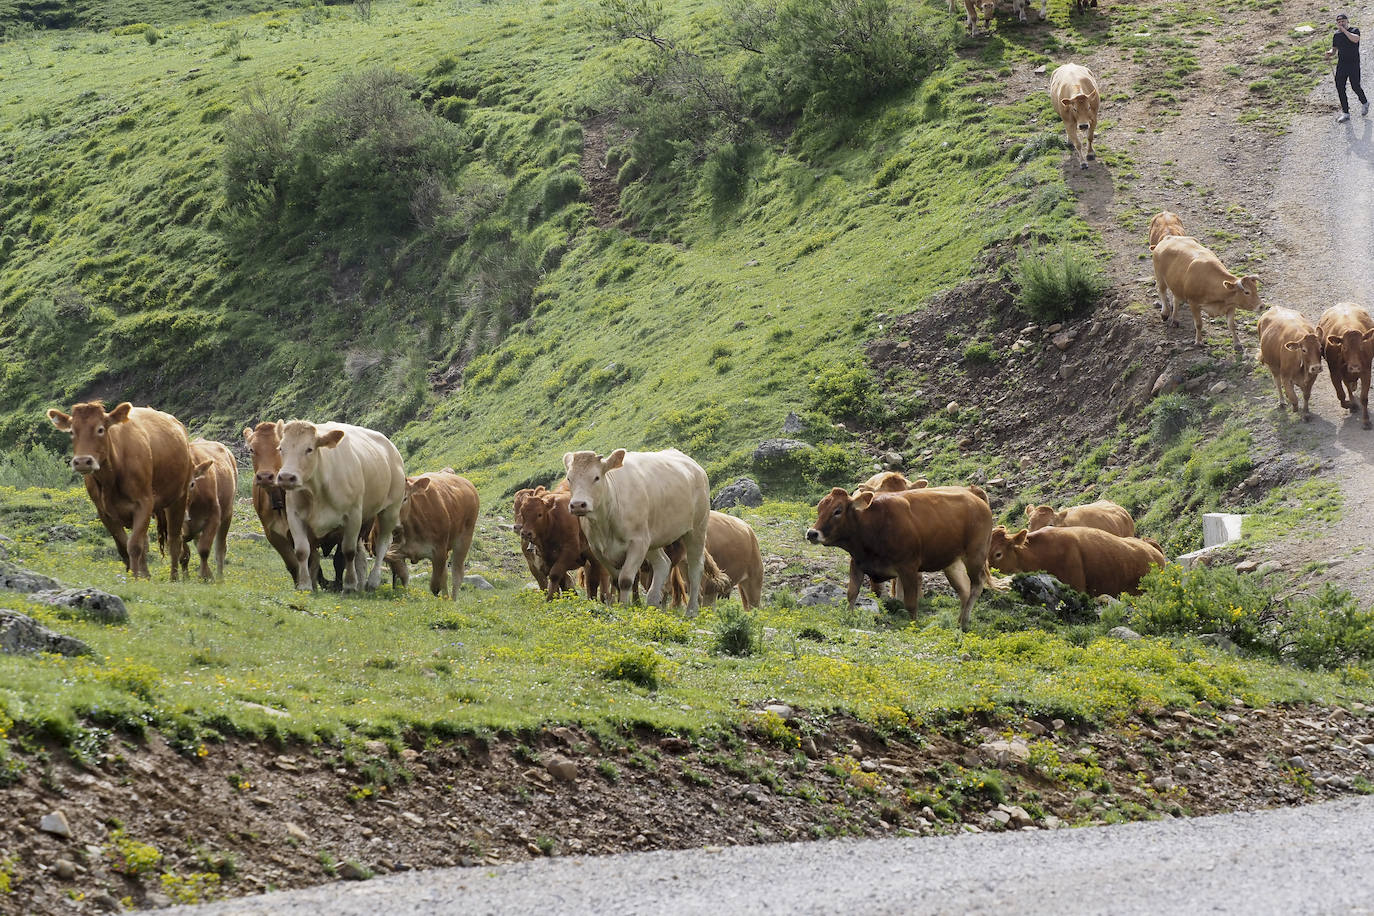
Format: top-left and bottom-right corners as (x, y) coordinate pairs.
(563, 449), (710, 615)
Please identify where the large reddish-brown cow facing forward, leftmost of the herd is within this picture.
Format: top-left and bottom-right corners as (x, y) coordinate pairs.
(48, 401), (191, 582)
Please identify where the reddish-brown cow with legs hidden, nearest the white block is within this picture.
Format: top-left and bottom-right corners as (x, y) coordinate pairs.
(988, 525), (1165, 596)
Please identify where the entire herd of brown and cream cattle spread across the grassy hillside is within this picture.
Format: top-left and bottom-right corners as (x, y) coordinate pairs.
(40, 59), (1374, 629)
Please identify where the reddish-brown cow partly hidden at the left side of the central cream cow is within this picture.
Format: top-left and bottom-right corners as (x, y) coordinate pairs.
(515, 485), (610, 600)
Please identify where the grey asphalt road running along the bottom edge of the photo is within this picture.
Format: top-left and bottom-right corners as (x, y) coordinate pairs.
(185, 798), (1374, 916)
